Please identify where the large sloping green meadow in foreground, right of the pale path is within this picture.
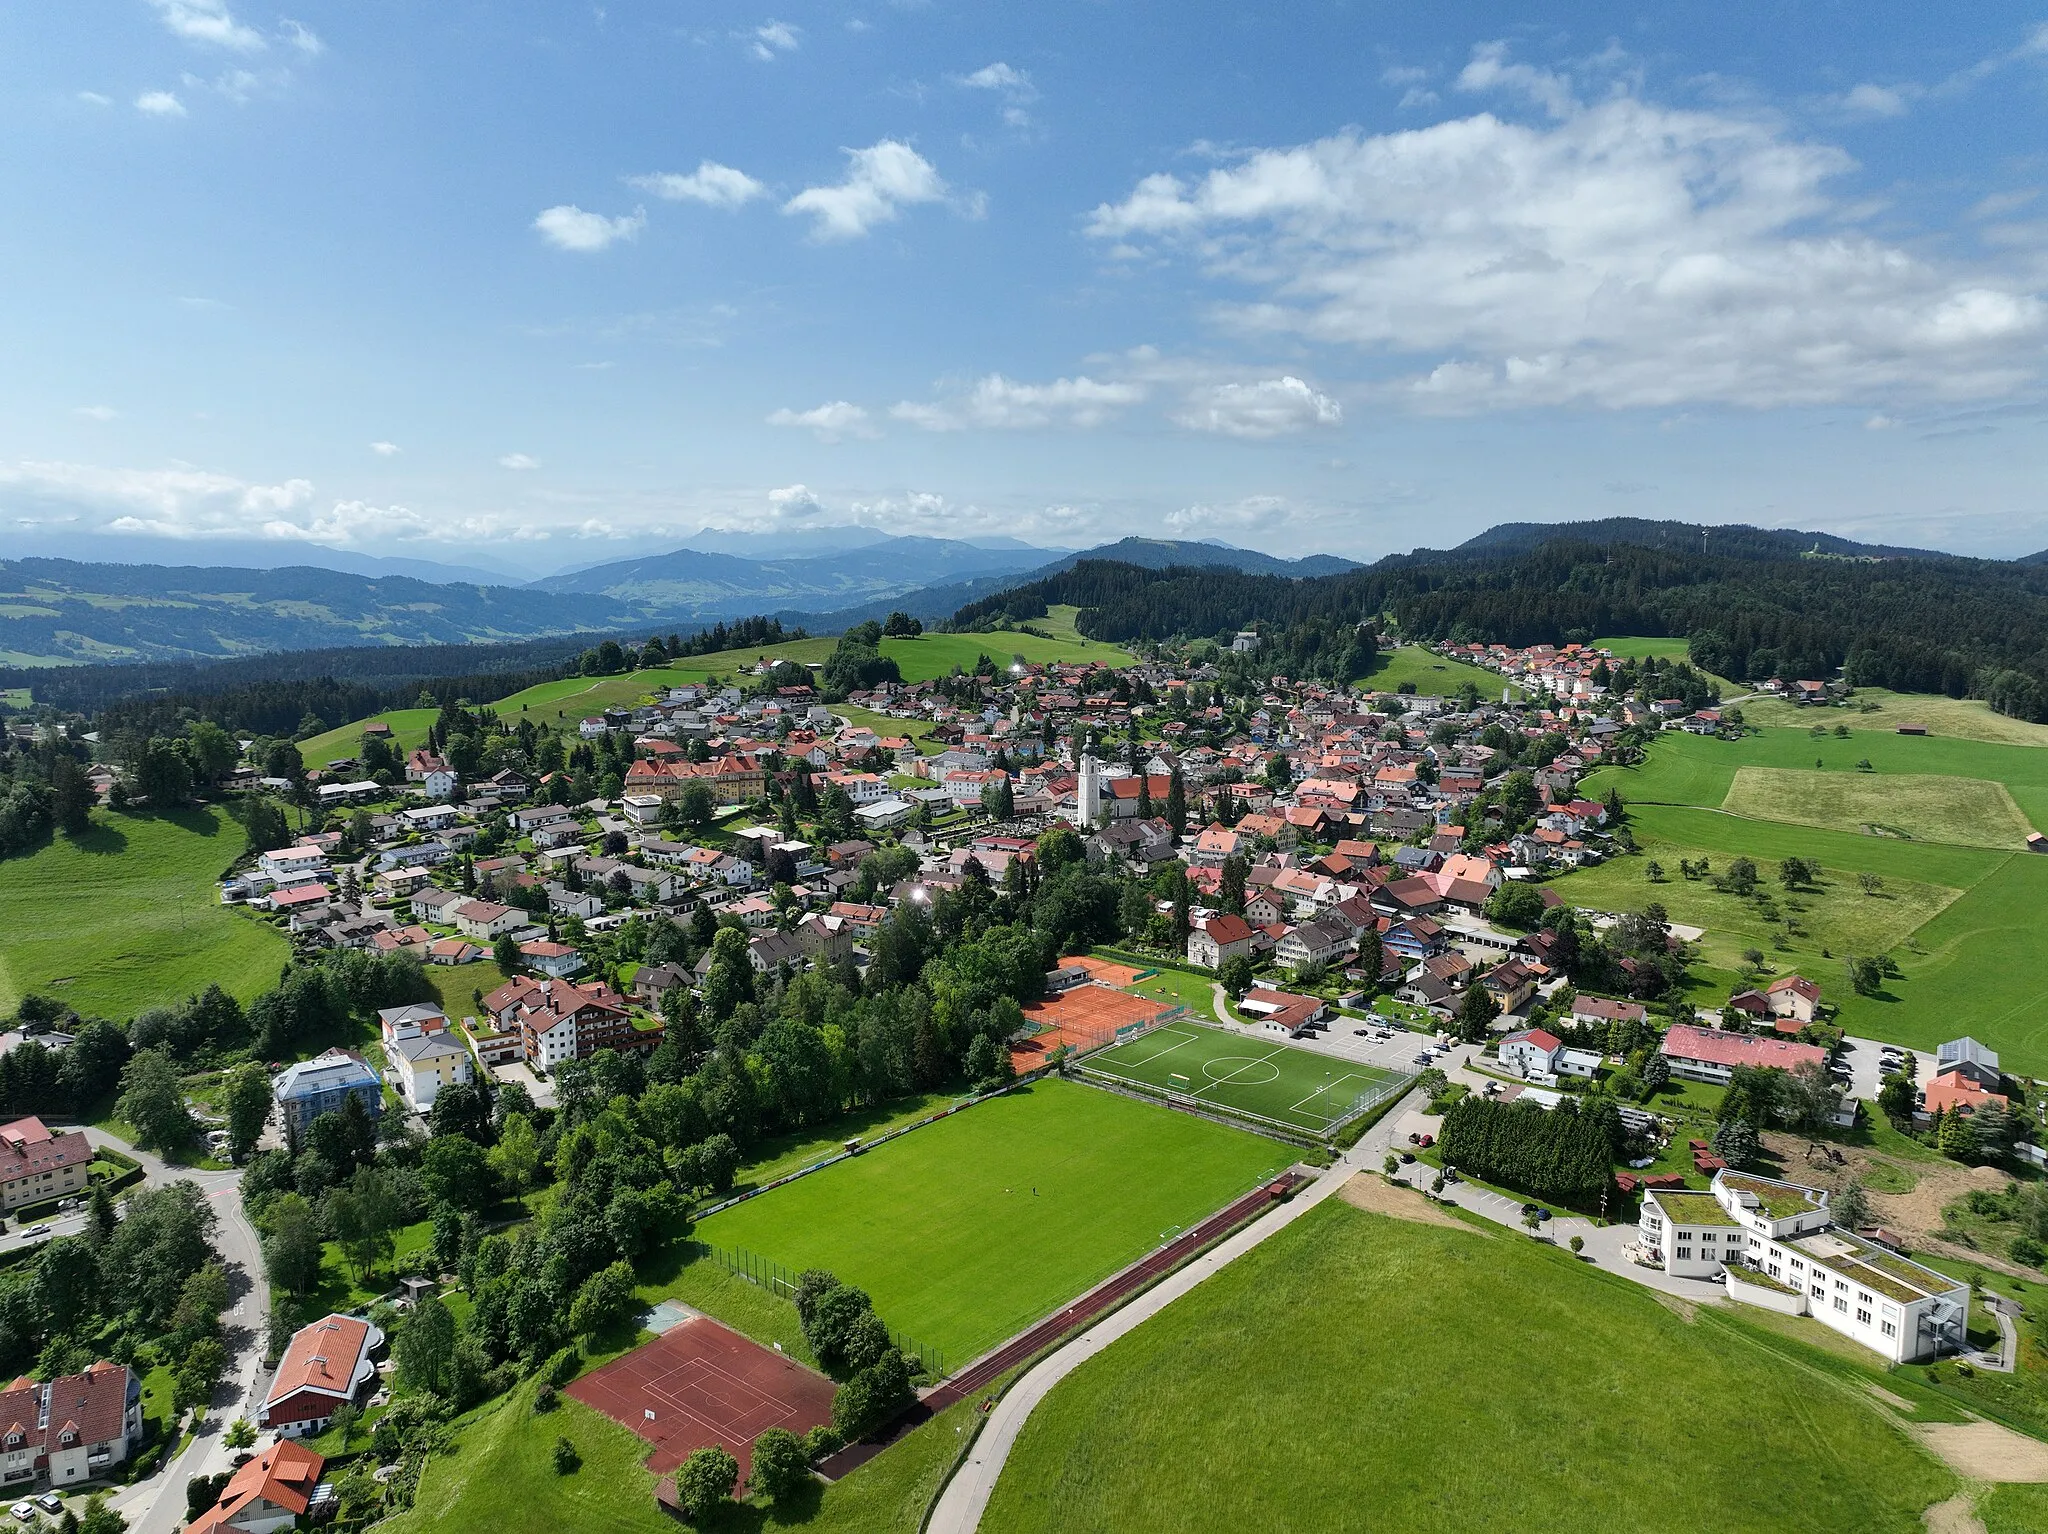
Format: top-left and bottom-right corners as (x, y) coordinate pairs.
(981, 1200), (1956, 1534)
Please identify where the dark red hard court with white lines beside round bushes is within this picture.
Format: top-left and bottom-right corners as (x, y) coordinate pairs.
(567, 1317), (834, 1477)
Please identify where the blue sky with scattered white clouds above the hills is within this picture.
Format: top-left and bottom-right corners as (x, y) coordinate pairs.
(0, 0), (2048, 569)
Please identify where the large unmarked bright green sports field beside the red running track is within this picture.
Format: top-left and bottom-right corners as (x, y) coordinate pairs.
(696, 1081), (1292, 1368)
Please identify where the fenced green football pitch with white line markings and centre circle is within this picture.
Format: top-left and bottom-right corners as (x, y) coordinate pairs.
(1083, 1022), (1403, 1135)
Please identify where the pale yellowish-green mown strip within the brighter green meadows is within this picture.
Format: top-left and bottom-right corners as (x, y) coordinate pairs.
(1720, 766), (2034, 850)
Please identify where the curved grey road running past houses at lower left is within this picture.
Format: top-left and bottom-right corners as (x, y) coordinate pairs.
(57, 1124), (270, 1534)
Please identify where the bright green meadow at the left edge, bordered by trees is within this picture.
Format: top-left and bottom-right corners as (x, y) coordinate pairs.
(0, 805), (291, 1022)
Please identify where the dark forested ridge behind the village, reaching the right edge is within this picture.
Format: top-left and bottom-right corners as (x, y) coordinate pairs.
(954, 522), (2048, 719)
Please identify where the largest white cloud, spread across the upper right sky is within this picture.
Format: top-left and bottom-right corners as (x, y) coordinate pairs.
(1090, 47), (2048, 410)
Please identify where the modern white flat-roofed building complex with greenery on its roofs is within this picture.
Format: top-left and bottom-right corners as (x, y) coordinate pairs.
(1638, 1171), (1970, 1364)
